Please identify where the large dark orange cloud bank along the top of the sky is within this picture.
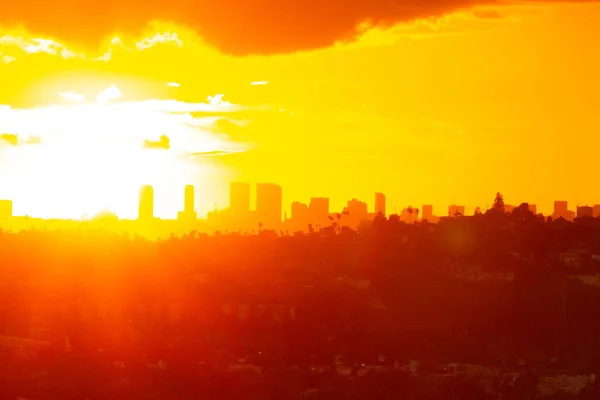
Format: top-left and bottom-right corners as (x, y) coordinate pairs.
(0, 0), (576, 55)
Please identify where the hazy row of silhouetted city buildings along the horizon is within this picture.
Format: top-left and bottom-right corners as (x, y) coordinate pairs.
(0, 181), (600, 223)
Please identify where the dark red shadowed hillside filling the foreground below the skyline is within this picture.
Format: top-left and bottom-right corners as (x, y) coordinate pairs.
(0, 195), (600, 400)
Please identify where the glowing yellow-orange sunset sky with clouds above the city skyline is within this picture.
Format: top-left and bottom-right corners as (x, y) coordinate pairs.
(0, 0), (600, 218)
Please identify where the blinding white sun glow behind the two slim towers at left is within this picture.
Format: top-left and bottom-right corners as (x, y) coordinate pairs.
(0, 86), (244, 218)
